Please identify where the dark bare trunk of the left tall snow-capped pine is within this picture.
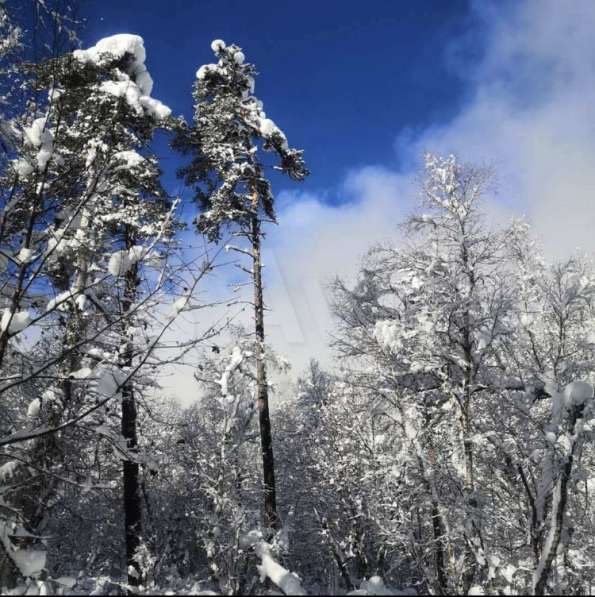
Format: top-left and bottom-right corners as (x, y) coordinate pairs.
(120, 234), (142, 594)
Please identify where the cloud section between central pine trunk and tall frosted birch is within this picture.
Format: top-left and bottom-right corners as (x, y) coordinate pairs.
(265, 167), (415, 370)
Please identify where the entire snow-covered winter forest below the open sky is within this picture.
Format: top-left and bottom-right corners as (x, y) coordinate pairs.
(0, 0), (595, 595)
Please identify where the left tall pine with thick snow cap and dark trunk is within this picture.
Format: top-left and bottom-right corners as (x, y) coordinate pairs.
(66, 35), (174, 586)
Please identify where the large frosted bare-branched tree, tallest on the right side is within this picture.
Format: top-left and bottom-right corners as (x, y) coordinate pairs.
(334, 156), (593, 593)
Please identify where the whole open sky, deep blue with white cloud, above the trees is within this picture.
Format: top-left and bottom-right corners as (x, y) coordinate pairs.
(84, 0), (595, 397)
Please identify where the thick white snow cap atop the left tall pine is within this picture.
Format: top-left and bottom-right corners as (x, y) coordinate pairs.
(73, 33), (171, 120)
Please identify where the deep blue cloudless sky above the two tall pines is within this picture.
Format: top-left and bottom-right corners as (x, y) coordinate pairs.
(82, 0), (476, 201)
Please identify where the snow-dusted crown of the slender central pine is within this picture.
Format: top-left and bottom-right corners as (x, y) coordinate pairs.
(177, 39), (308, 239)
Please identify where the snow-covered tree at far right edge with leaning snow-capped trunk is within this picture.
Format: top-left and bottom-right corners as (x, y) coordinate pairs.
(494, 232), (595, 594)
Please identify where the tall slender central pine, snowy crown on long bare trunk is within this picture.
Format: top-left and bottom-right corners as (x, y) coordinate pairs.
(176, 40), (307, 529)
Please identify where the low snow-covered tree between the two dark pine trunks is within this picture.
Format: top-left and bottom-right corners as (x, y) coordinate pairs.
(138, 326), (296, 594)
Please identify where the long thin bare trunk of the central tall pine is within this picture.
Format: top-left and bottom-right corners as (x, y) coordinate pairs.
(251, 191), (280, 531)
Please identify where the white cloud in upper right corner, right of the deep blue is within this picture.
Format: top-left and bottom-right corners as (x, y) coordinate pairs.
(409, 0), (595, 257)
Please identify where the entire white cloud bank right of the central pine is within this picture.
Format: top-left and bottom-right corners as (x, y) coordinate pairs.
(165, 0), (595, 400)
